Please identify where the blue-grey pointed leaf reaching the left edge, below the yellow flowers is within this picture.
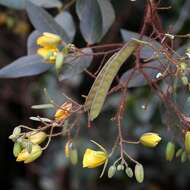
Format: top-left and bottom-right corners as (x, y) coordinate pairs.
(0, 55), (52, 78)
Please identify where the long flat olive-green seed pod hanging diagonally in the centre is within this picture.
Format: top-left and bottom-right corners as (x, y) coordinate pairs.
(84, 41), (138, 121)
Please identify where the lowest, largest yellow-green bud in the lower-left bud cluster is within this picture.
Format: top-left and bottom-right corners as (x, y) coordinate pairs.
(16, 145), (42, 164)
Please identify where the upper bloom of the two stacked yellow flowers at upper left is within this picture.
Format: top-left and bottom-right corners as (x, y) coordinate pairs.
(37, 32), (61, 48)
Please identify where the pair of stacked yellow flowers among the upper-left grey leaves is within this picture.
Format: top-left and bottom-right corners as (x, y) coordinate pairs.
(37, 32), (62, 64)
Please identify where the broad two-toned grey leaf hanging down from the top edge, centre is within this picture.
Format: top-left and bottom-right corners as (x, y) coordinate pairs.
(76, 0), (115, 44)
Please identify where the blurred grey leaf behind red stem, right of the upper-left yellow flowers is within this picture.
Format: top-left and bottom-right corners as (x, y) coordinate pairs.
(59, 48), (93, 80)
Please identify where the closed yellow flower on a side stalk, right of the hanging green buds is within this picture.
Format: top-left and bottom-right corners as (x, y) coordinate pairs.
(140, 133), (161, 147)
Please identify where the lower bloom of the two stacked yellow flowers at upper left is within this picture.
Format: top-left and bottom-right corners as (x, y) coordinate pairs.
(37, 47), (58, 64)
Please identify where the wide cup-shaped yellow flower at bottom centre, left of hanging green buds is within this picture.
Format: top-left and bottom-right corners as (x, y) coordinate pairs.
(83, 149), (108, 168)
